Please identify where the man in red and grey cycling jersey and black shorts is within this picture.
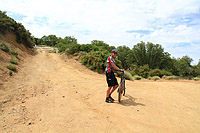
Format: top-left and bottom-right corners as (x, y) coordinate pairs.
(105, 49), (124, 103)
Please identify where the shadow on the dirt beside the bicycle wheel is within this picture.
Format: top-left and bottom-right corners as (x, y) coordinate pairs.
(119, 95), (146, 106)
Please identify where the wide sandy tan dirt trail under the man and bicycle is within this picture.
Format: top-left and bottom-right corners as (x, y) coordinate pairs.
(0, 52), (200, 133)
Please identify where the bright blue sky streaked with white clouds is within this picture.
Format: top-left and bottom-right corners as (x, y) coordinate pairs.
(0, 0), (200, 65)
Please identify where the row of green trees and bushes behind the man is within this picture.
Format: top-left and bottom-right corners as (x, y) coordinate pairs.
(34, 35), (200, 79)
